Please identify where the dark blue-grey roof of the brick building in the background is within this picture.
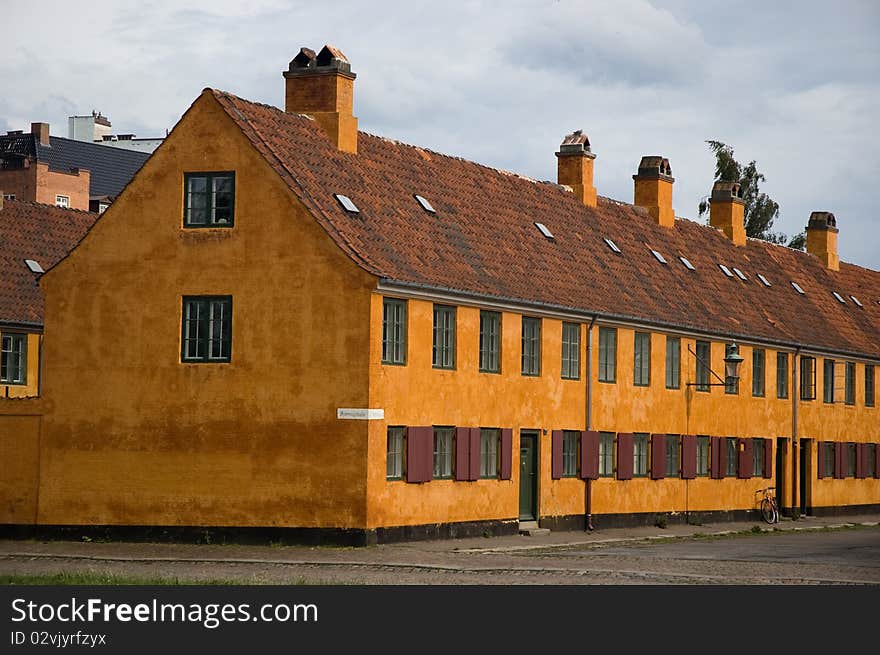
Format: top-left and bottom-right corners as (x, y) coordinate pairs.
(0, 134), (150, 198)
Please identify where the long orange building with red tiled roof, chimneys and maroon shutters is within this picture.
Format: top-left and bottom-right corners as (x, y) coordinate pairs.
(0, 46), (880, 543)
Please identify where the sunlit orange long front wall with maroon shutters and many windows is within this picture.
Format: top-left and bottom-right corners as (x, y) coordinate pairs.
(368, 302), (880, 526)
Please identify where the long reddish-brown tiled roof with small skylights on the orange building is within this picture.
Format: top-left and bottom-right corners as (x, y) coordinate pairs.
(218, 90), (880, 358)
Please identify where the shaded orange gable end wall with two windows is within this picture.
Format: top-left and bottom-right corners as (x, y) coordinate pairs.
(38, 92), (375, 527)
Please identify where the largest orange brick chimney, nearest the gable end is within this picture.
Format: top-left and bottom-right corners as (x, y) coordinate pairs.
(284, 45), (357, 154)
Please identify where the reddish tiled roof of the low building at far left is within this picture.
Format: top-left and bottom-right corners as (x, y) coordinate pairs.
(0, 200), (99, 326)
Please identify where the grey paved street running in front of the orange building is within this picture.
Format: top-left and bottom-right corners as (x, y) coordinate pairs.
(0, 524), (880, 585)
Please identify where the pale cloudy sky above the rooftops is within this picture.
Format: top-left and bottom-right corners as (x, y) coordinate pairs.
(6, 0), (880, 270)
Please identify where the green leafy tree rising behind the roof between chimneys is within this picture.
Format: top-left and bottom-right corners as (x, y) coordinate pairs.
(699, 141), (806, 250)
